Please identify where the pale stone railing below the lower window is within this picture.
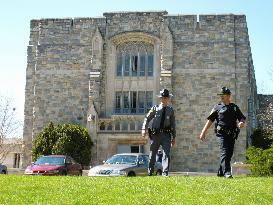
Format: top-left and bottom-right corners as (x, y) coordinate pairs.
(98, 115), (144, 132)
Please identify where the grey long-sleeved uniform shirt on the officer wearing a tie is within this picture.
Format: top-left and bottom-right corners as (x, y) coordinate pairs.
(142, 104), (176, 138)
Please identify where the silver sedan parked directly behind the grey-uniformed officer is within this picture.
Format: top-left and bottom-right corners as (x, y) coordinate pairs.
(88, 153), (162, 176)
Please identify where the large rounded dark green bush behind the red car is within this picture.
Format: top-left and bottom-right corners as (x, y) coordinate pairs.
(32, 122), (93, 165)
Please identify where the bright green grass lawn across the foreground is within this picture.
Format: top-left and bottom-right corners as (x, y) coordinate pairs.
(0, 175), (273, 205)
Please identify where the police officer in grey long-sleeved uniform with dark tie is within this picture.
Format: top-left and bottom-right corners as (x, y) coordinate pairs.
(142, 89), (176, 176)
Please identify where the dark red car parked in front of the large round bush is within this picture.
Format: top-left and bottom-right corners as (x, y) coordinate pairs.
(25, 155), (82, 176)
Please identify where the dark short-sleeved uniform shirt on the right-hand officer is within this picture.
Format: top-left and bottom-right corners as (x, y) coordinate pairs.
(207, 102), (246, 129)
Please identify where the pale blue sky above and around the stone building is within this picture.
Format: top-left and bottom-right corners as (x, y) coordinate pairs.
(0, 0), (273, 136)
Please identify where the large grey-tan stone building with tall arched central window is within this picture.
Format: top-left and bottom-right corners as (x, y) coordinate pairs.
(24, 11), (256, 171)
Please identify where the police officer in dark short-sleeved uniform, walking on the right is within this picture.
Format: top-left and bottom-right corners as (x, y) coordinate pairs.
(200, 87), (246, 178)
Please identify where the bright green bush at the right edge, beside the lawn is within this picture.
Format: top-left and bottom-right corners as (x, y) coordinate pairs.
(246, 147), (273, 176)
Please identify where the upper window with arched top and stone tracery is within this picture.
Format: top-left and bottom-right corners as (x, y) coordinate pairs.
(116, 42), (154, 76)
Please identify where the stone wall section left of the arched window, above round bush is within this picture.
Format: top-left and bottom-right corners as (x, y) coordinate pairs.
(24, 18), (105, 167)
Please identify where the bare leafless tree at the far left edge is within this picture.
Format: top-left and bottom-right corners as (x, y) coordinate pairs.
(0, 96), (22, 163)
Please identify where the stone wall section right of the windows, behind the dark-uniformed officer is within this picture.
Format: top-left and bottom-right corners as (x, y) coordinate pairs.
(166, 15), (256, 171)
